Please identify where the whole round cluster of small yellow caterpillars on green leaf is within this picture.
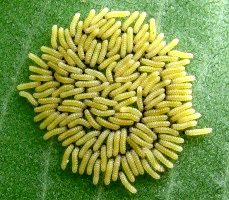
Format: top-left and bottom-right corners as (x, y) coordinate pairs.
(17, 8), (212, 193)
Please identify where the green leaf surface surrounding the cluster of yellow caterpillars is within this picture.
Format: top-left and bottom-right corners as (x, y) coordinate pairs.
(0, 0), (229, 200)
